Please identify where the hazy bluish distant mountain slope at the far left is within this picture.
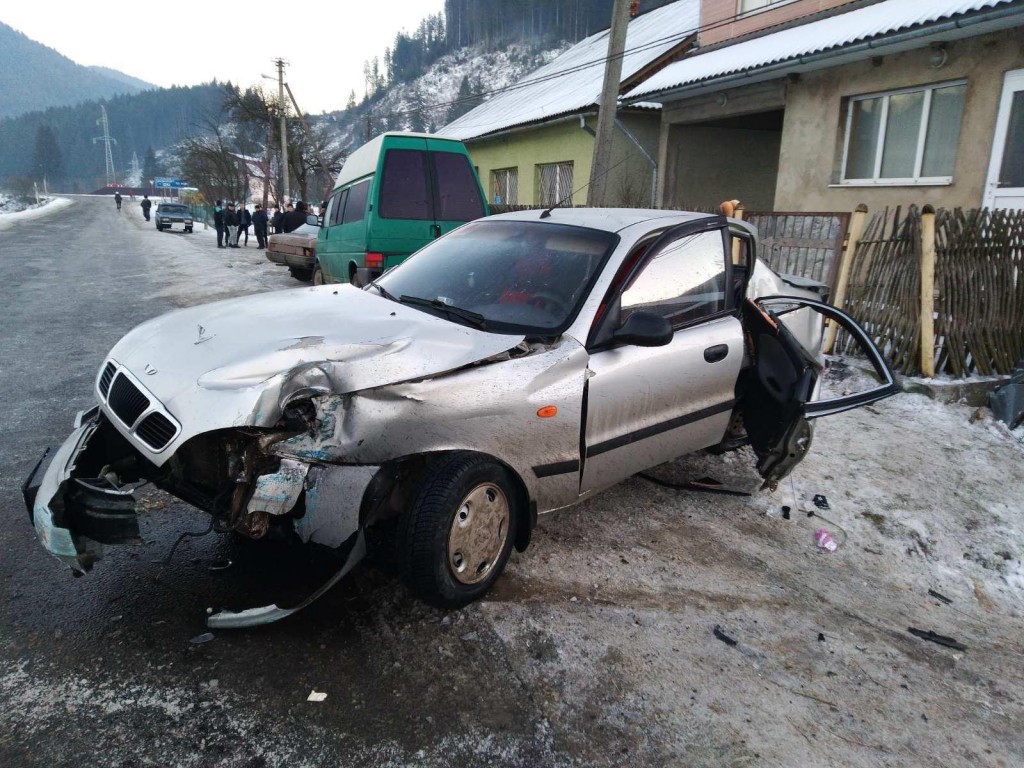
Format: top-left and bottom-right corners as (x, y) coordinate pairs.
(0, 23), (154, 118)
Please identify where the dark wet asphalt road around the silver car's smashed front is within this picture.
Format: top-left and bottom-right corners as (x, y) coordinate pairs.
(0, 198), (557, 766)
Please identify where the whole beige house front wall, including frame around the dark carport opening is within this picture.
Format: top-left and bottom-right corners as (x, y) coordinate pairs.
(659, 29), (1024, 211)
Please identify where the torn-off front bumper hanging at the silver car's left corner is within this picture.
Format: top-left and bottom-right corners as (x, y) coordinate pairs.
(22, 408), (139, 573)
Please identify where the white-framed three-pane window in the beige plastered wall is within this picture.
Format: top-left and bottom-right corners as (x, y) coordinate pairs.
(842, 80), (967, 184)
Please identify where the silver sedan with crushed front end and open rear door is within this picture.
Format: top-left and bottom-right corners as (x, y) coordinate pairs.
(24, 209), (896, 627)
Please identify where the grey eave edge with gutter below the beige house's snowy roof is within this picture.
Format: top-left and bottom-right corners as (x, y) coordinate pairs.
(624, 4), (1024, 104)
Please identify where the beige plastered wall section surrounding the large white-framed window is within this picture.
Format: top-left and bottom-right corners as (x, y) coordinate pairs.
(775, 30), (1024, 211)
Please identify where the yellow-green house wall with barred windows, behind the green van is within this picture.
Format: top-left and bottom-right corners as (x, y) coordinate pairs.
(465, 112), (660, 207)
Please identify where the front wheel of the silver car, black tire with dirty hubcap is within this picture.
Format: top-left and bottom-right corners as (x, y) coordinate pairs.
(396, 452), (523, 608)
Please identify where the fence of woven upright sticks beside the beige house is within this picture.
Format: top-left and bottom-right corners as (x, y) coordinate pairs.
(835, 206), (1024, 377)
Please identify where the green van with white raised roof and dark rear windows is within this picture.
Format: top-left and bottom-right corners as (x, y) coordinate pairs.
(313, 133), (487, 286)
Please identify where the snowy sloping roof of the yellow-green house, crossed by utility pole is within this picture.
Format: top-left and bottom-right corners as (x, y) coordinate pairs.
(437, 0), (700, 139)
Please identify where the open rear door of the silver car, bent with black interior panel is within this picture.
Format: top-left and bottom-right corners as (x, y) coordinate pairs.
(740, 296), (899, 488)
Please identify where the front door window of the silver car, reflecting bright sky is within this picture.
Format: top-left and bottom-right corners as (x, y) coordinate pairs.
(621, 229), (727, 328)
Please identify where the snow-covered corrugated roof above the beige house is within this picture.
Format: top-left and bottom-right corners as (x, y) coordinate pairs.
(626, 0), (1014, 99)
